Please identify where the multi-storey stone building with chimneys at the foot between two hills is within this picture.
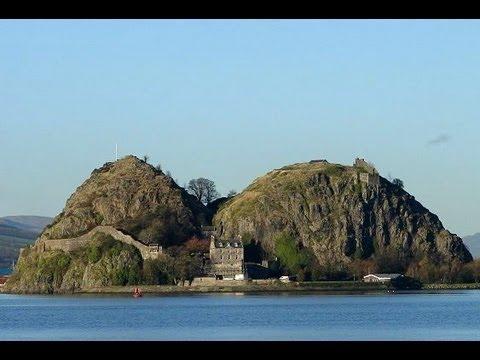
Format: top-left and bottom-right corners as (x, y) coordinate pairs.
(209, 235), (245, 280)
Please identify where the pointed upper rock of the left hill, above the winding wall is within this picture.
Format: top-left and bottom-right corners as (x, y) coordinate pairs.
(41, 156), (206, 246)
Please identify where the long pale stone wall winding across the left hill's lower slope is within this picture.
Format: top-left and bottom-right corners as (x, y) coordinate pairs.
(35, 226), (162, 260)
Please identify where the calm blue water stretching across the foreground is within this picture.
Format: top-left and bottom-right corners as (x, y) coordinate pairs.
(0, 290), (480, 340)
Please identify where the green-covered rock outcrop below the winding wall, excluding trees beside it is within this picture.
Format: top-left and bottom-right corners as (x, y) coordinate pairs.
(7, 234), (143, 293)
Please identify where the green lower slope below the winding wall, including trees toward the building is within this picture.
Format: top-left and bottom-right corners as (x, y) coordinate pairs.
(6, 233), (208, 294)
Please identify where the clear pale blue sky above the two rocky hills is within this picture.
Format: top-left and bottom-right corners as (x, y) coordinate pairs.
(0, 20), (480, 236)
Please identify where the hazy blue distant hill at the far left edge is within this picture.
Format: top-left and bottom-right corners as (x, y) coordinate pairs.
(0, 216), (53, 268)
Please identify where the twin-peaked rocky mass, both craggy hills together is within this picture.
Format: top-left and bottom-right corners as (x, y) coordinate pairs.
(4, 156), (472, 293)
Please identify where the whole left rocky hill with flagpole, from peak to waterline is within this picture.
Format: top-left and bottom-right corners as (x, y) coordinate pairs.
(5, 156), (211, 293)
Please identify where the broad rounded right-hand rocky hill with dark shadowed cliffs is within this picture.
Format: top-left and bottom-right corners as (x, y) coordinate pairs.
(214, 163), (472, 263)
